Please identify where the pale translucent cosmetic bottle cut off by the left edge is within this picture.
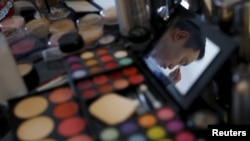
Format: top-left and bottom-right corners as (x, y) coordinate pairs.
(0, 33), (27, 105)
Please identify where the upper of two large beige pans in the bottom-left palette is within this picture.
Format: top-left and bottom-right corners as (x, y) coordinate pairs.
(14, 96), (48, 118)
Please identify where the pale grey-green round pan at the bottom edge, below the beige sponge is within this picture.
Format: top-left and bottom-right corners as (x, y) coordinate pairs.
(100, 127), (120, 141)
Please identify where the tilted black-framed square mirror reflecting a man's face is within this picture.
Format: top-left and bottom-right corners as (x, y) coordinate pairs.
(142, 3), (236, 109)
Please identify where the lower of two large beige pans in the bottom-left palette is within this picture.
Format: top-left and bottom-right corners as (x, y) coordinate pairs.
(17, 116), (55, 140)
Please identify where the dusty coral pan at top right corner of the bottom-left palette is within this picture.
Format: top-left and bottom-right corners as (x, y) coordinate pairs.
(49, 87), (73, 103)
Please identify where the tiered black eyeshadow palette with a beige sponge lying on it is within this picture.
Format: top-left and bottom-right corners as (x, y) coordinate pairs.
(62, 47), (195, 141)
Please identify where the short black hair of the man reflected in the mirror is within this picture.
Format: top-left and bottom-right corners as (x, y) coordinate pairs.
(173, 19), (206, 60)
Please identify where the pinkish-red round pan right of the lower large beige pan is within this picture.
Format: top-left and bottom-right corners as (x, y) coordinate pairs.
(57, 117), (86, 137)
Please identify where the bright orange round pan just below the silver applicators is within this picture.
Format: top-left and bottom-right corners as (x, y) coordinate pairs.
(138, 114), (156, 128)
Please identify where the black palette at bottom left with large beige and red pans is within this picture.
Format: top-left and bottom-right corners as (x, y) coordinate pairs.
(9, 85), (93, 141)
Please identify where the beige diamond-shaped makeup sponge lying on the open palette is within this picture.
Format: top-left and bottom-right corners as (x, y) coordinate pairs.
(89, 93), (137, 125)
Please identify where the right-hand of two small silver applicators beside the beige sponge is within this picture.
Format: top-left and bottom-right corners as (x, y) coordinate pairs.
(139, 84), (162, 109)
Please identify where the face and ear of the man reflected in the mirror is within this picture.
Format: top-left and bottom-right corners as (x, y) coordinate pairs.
(153, 29), (200, 69)
